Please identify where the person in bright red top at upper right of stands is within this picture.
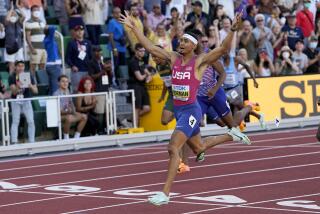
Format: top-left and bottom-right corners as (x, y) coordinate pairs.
(297, 0), (315, 38)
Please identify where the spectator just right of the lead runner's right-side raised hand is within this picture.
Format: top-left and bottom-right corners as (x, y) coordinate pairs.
(238, 20), (258, 60)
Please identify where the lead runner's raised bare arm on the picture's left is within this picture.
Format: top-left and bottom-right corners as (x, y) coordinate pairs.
(120, 11), (172, 61)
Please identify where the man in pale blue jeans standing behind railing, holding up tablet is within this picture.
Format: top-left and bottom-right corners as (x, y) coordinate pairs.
(9, 61), (38, 144)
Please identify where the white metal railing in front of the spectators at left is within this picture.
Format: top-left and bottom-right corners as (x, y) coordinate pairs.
(0, 90), (136, 146)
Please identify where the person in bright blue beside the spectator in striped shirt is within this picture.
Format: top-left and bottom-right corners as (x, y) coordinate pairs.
(44, 26), (61, 95)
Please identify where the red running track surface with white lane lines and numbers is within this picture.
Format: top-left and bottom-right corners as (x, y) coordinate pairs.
(0, 129), (320, 214)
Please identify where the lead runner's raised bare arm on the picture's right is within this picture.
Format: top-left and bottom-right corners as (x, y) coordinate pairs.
(200, 12), (242, 66)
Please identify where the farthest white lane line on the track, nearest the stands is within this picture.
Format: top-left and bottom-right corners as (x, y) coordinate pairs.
(0, 132), (314, 172)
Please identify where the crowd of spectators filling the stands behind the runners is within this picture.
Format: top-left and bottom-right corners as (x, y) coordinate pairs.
(0, 0), (320, 143)
